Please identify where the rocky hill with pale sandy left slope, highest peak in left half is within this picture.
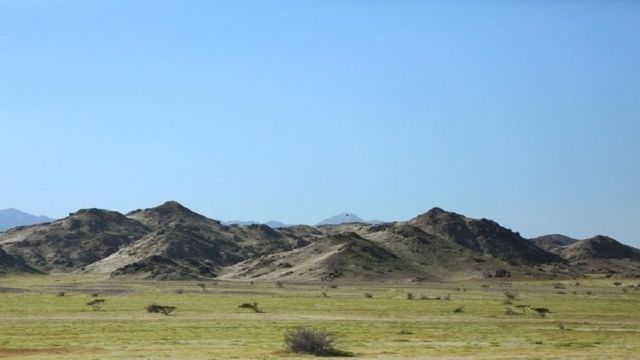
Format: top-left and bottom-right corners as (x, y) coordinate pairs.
(85, 201), (307, 279)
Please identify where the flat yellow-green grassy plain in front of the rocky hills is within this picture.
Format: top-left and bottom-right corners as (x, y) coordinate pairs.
(0, 275), (640, 359)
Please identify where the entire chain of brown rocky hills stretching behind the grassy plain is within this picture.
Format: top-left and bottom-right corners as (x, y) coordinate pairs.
(0, 201), (640, 281)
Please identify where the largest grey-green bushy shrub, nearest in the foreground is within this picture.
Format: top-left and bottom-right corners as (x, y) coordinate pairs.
(284, 327), (350, 356)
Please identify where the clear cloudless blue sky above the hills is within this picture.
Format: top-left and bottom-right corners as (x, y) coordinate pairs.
(0, 0), (640, 246)
